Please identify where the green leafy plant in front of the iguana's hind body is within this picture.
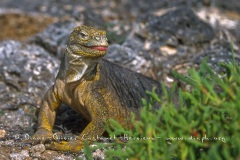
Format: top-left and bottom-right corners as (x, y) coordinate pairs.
(83, 57), (240, 160)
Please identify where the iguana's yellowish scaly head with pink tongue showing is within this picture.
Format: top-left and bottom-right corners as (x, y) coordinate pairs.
(68, 25), (108, 58)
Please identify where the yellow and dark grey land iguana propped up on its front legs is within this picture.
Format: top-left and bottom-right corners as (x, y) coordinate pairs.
(33, 25), (161, 152)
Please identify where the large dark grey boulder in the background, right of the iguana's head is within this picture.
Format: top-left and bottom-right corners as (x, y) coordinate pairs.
(137, 8), (214, 46)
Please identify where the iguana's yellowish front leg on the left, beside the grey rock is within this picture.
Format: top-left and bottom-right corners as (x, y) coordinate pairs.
(32, 86), (61, 142)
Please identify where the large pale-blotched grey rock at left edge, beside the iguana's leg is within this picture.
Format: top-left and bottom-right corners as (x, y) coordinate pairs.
(0, 41), (59, 127)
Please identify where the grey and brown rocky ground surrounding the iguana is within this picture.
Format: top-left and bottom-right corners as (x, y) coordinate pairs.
(0, 0), (240, 160)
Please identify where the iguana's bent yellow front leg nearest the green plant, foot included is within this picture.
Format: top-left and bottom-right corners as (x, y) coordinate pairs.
(46, 94), (109, 152)
